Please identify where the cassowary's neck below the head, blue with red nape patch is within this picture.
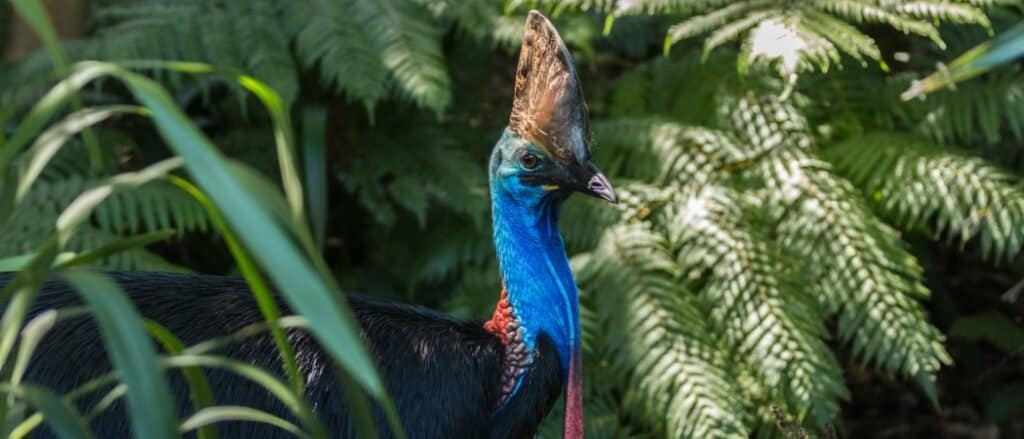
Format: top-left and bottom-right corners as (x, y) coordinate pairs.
(484, 183), (580, 405)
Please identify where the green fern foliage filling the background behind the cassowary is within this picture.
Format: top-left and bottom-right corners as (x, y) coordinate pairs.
(0, 0), (1024, 437)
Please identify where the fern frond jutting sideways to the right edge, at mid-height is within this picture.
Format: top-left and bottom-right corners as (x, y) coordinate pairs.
(825, 132), (1024, 261)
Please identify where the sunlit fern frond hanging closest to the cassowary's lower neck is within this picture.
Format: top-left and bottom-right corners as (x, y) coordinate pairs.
(580, 223), (746, 438)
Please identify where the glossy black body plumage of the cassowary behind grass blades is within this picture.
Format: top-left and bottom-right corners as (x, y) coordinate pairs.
(0, 272), (564, 438)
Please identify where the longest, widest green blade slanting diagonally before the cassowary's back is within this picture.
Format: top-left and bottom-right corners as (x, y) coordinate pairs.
(79, 61), (385, 398)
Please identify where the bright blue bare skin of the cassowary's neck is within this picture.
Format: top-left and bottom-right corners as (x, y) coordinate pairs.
(490, 129), (580, 371)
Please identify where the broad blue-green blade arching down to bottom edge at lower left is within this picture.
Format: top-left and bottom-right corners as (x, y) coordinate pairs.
(63, 270), (178, 439)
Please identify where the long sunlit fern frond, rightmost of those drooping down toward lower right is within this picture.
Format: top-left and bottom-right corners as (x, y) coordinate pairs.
(721, 94), (949, 396)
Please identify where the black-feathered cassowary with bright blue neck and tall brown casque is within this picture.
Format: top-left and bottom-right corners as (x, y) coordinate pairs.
(6, 11), (616, 438)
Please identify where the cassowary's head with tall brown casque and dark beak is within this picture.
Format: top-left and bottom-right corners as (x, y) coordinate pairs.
(490, 10), (617, 205)
